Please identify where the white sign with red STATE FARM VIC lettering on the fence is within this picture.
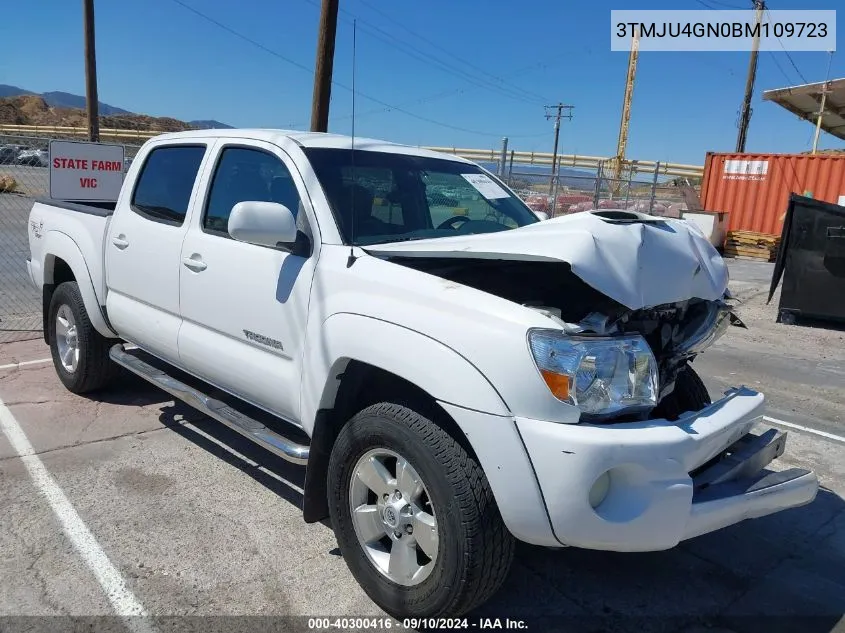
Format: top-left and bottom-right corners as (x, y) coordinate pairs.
(50, 141), (123, 202)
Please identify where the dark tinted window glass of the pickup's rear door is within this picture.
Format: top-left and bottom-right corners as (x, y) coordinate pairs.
(131, 145), (205, 226)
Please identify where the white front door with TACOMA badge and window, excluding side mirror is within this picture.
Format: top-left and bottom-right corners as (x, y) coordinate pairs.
(179, 141), (317, 421)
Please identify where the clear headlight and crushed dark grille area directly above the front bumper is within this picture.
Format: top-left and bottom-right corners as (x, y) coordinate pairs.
(527, 297), (741, 422)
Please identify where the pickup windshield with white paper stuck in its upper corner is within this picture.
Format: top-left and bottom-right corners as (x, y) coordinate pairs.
(304, 147), (539, 246)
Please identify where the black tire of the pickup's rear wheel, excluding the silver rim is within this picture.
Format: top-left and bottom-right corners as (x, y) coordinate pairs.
(48, 281), (117, 394)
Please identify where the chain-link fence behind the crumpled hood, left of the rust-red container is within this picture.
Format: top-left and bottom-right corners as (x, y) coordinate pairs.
(504, 161), (696, 218)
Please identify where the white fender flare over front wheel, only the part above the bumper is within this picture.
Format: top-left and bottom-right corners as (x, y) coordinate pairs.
(302, 313), (510, 433)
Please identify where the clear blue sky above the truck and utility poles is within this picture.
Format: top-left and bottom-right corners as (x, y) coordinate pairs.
(0, 0), (845, 164)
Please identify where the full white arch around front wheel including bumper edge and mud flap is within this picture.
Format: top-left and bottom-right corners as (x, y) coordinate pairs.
(302, 313), (560, 546)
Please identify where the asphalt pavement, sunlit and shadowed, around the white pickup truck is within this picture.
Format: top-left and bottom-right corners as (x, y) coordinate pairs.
(0, 262), (845, 633)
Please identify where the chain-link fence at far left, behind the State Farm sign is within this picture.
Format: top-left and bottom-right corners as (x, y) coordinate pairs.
(0, 135), (138, 343)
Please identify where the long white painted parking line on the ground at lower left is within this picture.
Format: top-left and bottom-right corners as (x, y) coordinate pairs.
(0, 392), (155, 633)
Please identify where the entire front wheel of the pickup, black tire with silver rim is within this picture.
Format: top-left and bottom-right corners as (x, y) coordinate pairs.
(328, 403), (514, 618)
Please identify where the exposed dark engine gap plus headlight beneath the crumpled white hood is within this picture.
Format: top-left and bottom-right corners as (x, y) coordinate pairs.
(392, 257), (742, 422)
